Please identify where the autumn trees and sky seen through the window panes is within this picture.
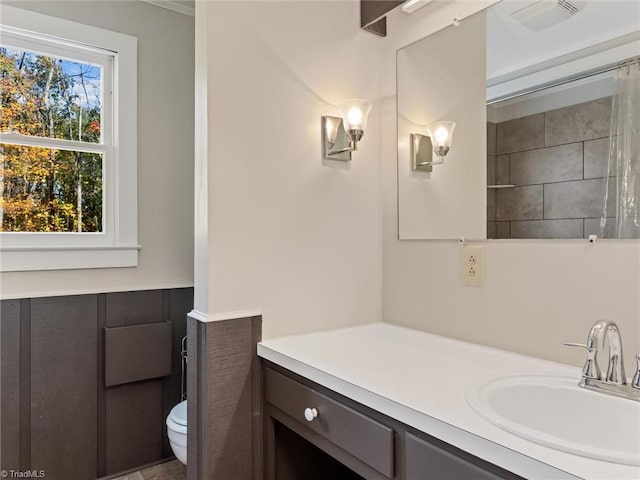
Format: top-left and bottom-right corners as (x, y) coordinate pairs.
(0, 48), (103, 232)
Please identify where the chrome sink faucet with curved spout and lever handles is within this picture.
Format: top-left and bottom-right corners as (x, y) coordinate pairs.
(565, 320), (640, 401)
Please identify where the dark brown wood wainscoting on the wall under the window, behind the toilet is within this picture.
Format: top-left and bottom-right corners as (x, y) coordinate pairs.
(0, 288), (193, 480)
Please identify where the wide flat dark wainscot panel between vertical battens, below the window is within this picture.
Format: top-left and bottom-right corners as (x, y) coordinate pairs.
(29, 295), (98, 479)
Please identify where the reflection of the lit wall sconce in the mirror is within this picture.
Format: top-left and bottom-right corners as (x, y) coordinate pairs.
(410, 122), (456, 172)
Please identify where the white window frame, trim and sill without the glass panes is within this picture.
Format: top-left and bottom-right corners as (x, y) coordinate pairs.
(0, 5), (140, 272)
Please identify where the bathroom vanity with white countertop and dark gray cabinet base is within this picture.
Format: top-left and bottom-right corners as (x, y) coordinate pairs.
(258, 324), (640, 480)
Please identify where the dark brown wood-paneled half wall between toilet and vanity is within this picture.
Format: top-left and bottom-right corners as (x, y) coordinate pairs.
(187, 316), (263, 480)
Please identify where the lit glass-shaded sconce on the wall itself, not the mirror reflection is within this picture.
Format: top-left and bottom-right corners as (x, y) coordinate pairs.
(321, 98), (371, 162)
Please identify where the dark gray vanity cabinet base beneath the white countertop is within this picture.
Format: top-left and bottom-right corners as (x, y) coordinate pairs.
(264, 361), (521, 480)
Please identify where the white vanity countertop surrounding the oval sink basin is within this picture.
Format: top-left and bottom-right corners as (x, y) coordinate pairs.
(258, 323), (640, 480)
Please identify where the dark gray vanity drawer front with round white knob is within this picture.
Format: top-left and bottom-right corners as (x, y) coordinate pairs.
(265, 368), (394, 478)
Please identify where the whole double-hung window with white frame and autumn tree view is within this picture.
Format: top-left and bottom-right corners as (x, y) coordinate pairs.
(0, 6), (139, 271)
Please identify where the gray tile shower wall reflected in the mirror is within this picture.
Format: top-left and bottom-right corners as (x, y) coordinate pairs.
(487, 97), (614, 238)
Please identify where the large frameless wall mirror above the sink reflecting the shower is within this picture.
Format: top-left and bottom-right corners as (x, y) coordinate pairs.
(396, 0), (640, 239)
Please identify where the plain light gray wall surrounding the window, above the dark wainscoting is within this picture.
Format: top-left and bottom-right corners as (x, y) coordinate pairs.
(0, 0), (194, 298)
